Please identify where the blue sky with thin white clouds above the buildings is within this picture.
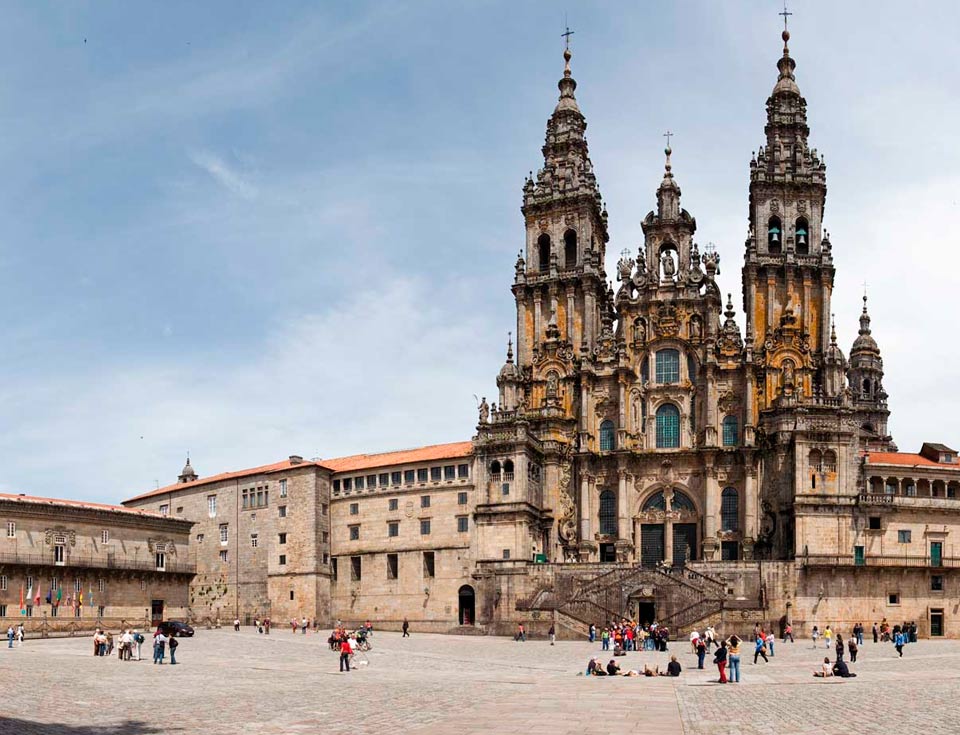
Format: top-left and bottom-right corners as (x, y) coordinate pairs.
(0, 0), (960, 501)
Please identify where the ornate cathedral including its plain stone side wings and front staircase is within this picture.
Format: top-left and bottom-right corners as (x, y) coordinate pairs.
(124, 24), (960, 636)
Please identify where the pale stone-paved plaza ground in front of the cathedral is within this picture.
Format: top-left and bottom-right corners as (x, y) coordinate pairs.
(0, 629), (960, 735)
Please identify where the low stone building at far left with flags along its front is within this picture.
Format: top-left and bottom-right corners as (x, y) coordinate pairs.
(0, 494), (195, 633)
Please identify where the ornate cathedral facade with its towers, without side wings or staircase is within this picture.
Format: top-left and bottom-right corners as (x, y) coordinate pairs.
(474, 31), (892, 564)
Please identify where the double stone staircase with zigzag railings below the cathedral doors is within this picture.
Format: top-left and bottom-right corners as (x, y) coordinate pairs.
(517, 564), (756, 635)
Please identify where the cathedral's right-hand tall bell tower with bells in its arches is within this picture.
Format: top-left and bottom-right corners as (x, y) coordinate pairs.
(743, 23), (834, 412)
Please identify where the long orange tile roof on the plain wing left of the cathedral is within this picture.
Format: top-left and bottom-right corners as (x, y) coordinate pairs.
(123, 441), (473, 504)
